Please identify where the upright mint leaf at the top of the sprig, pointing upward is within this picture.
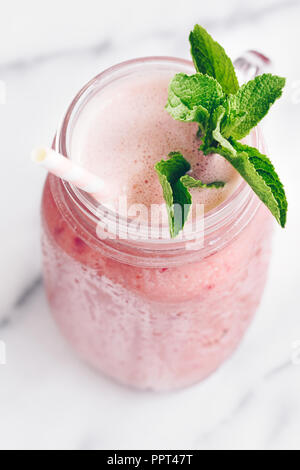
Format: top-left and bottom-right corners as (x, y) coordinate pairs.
(190, 25), (239, 94)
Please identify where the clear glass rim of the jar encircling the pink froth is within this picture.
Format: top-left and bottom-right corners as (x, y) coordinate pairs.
(54, 56), (261, 262)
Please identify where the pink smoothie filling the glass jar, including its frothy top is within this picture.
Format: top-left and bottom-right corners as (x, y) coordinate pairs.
(42, 58), (272, 390)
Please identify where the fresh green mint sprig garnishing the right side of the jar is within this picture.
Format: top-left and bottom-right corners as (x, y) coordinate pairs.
(158, 25), (287, 234)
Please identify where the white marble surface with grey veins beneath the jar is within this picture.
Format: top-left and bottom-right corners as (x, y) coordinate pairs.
(0, 0), (300, 449)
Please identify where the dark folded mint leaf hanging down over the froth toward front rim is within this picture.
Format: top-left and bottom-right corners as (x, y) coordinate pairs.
(155, 152), (192, 238)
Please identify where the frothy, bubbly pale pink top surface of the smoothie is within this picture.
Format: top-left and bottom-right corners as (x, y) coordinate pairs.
(71, 70), (240, 218)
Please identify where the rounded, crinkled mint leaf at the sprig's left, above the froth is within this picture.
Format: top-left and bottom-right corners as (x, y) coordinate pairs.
(166, 73), (224, 133)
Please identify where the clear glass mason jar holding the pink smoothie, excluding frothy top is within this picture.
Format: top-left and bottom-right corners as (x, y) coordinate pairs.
(42, 57), (272, 390)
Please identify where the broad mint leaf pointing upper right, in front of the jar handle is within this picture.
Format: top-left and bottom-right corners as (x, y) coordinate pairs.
(222, 73), (285, 139)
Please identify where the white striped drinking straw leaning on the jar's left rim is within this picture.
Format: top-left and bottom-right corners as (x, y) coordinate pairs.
(31, 147), (107, 198)
